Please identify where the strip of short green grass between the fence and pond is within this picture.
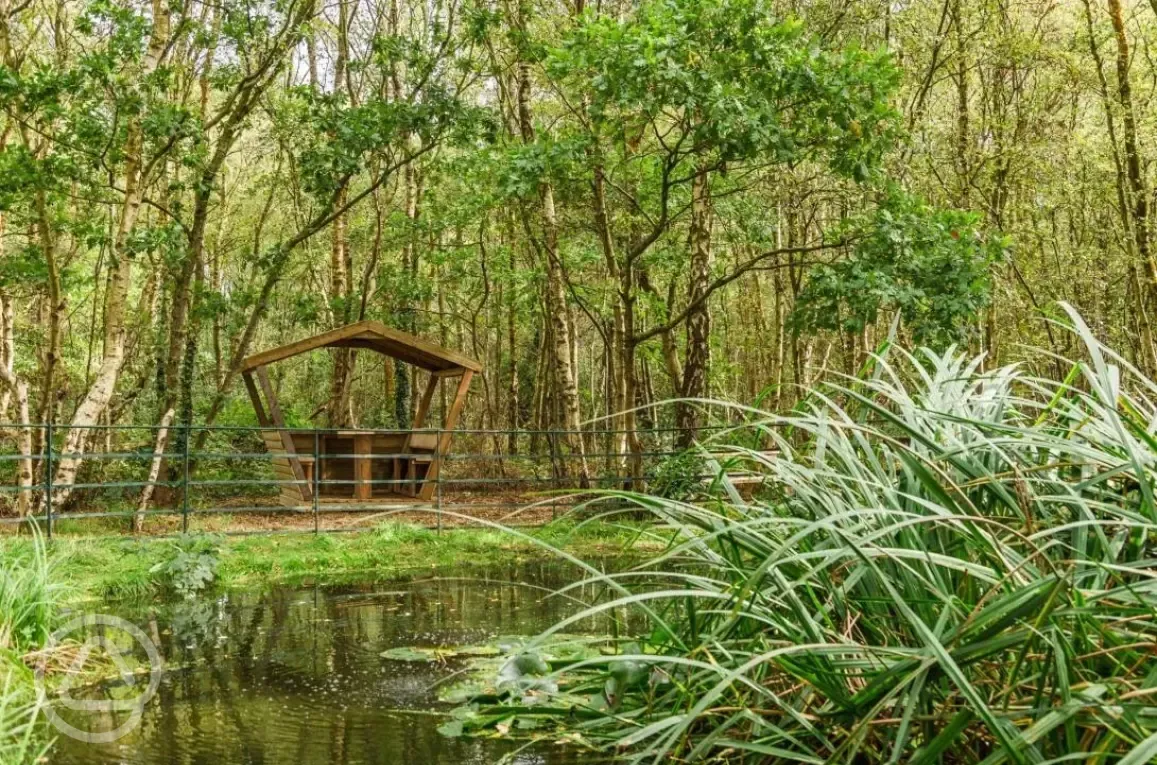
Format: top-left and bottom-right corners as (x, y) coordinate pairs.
(0, 520), (656, 601)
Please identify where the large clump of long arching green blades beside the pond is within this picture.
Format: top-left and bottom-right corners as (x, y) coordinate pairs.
(470, 311), (1157, 765)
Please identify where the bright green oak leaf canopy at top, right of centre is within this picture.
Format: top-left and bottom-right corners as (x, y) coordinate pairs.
(546, 0), (899, 178)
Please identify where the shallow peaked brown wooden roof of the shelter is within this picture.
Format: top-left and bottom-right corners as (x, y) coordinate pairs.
(241, 321), (482, 373)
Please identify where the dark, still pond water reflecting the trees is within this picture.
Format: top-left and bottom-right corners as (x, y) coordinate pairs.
(51, 557), (624, 765)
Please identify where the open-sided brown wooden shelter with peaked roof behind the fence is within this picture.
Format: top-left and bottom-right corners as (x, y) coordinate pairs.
(241, 321), (482, 507)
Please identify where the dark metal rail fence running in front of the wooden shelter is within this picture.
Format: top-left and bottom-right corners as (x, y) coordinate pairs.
(0, 424), (749, 537)
